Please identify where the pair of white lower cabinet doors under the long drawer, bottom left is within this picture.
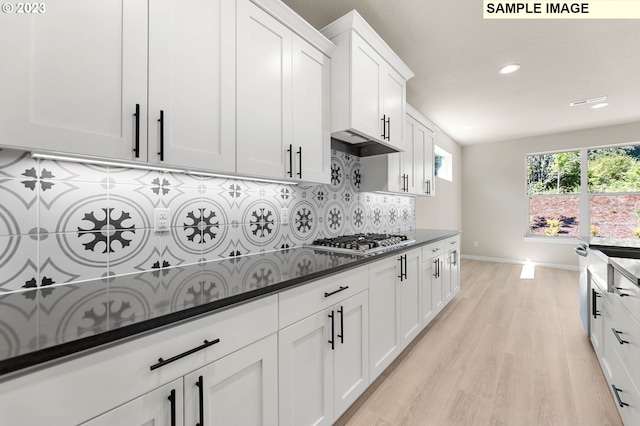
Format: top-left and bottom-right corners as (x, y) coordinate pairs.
(84, 334), (278, 426)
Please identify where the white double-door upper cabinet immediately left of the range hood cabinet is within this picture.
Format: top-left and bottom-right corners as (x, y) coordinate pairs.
(236, 0), (333, 183)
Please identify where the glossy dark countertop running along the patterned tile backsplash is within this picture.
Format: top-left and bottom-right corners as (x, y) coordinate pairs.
(0, 229), (459, 380)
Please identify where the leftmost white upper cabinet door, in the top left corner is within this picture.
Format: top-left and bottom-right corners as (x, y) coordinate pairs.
(0, 0), (147, 161)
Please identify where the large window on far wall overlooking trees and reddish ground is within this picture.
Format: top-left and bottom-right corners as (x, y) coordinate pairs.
(526, 145), (640, 238)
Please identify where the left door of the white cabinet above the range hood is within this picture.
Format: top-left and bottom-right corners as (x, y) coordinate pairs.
(350, 32), (383, 140)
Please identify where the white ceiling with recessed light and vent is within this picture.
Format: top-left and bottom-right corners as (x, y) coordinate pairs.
(283, 0), (640, 145)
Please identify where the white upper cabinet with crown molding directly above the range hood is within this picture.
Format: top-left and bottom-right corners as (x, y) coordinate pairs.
(322, 10), (414, 150)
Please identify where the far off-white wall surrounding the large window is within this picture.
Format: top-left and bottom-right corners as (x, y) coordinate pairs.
(460, 122), (640, 266)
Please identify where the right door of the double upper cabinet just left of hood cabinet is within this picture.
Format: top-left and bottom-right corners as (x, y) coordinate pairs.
(292, 35), (331, 183)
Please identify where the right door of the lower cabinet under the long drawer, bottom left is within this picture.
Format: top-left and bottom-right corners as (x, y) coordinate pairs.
(184, 334), (278, 425)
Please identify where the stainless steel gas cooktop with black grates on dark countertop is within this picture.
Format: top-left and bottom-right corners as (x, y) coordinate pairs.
(310, 234), (416, 255)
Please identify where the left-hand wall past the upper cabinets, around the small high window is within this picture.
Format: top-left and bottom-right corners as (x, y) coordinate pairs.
(416, 132), (462, 230)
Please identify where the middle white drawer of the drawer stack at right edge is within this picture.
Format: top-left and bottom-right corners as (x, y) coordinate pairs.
(604, 299), (640, 387)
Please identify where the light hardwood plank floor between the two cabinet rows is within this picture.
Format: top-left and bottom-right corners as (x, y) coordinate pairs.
(336, 260), (622, 426)
